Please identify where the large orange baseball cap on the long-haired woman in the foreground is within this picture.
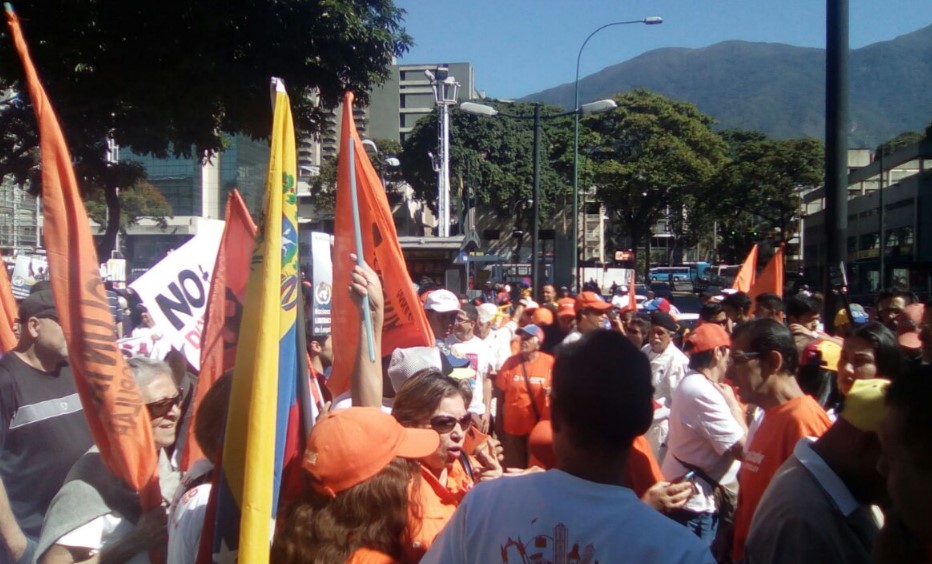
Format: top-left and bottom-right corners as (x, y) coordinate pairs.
(304, 407), (440, 497)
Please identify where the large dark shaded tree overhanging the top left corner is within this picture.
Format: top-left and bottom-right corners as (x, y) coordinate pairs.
(0, 0), (411, 254)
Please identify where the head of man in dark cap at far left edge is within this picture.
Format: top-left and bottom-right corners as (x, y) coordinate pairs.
(19, 290), (68, 365)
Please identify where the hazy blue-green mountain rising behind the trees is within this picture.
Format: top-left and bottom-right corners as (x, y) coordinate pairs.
(523, 25), (932, 147)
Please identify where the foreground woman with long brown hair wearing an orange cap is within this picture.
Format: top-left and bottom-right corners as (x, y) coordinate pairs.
(271, 407), (440, 564)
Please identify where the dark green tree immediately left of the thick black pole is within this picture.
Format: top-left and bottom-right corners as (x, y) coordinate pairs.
(711, 131), (825, 260)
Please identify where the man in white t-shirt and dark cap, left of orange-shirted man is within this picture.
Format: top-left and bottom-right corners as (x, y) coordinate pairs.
(447, 304), (492, 433)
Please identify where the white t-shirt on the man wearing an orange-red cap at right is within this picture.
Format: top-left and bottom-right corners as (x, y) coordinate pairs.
(661, 372), (744, 513)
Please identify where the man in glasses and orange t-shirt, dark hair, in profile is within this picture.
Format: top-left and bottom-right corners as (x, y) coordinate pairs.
(729, 319), (831, 562)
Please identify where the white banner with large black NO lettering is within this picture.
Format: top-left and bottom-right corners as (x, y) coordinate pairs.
(129, 220), (223, 370)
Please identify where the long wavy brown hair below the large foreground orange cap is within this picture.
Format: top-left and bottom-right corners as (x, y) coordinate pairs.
(271, 458), (420, 564)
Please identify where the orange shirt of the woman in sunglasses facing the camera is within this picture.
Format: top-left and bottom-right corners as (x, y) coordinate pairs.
(411, 459), (479, 557)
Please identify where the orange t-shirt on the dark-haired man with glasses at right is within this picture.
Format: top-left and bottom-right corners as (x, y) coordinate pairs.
(732, 395), (832, 562)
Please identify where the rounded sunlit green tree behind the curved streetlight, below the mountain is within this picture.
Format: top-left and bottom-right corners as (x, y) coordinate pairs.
(580, 90), (725, 266)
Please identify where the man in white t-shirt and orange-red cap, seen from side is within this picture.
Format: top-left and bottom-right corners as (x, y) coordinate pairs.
(662, 323), (747, 544)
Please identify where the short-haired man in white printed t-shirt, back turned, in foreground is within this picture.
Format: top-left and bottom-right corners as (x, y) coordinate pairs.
(421, 331), (713, 564)
